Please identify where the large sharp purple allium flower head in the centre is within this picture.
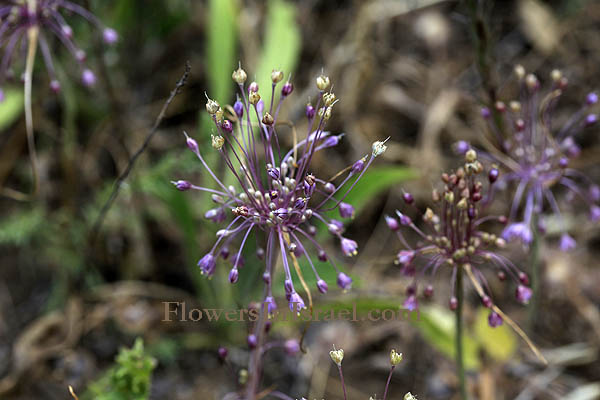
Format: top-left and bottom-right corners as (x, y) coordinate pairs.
(173, 67), (386, 313)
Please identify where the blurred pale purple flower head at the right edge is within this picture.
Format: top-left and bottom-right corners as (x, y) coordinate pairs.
(456, 65), (600, 251)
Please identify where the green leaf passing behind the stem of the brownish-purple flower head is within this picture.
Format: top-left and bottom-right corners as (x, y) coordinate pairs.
(414, 306), (479, 369)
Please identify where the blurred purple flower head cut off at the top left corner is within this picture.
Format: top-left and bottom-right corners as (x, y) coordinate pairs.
(0, 0), (118, 100)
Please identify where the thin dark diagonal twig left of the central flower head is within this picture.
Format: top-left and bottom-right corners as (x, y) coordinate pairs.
(90, 61), (191, 245)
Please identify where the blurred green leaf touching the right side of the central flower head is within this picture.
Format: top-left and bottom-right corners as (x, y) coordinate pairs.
(338, 166), (418, 214)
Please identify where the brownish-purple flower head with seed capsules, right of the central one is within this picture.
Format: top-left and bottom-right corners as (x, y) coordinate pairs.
(386, 149), (531, 326)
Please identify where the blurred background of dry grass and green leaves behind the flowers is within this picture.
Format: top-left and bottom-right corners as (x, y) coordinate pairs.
(0, 0), (600, 399)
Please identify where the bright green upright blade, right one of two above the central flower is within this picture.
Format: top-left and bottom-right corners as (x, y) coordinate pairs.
(256, 0), (302, 100)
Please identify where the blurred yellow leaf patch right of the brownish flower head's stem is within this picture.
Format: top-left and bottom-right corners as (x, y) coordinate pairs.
(475, 308), (517, 362)
